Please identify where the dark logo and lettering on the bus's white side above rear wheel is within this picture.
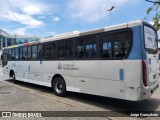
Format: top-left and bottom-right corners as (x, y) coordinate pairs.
(58, 63), (79, 70)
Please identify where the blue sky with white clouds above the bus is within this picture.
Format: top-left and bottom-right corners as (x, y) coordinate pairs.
(0, 0), (159, 37)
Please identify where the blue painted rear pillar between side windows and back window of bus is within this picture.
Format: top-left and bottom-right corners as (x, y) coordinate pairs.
(128, 26), (146, 60)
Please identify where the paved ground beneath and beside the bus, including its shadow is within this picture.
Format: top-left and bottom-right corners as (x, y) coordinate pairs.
(0, 66), (160, 120)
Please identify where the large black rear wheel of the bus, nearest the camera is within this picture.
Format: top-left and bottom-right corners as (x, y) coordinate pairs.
(52, 77), (66, 97)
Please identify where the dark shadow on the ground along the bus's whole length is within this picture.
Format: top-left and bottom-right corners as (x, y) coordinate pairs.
(5, 80), (160, 114)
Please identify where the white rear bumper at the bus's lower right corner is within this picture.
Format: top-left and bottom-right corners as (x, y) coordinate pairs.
(137, 80), (159, 101)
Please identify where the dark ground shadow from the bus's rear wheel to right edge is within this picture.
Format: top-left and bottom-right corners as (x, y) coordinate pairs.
(68, 92), (160, 111)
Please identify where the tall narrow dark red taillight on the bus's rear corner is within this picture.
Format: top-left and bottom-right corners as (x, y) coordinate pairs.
(142, 60), (147, 87)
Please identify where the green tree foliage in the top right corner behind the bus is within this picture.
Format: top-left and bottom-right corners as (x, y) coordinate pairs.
(145, 0), (160, 30)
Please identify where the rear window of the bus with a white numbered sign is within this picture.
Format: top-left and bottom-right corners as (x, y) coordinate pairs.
(144, 26), (158, 54)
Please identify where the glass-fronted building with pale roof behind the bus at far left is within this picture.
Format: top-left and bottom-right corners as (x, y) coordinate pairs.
(0, 29), (41, 51)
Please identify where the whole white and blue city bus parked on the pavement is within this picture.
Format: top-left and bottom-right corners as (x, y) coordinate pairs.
(3, 21), (159, 101)
